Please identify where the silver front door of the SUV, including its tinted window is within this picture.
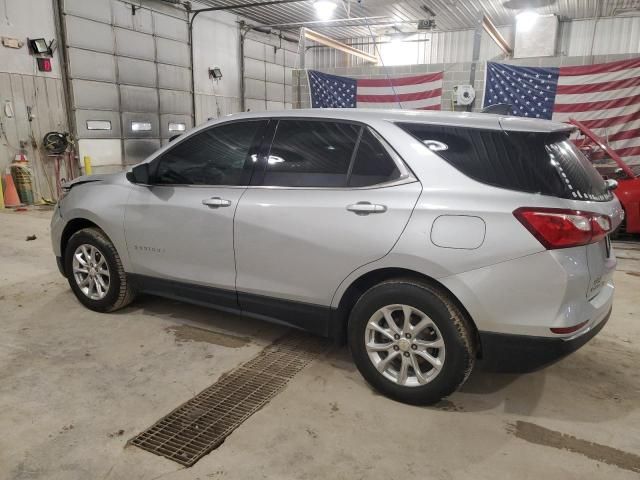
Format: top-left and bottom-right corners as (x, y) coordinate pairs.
(125, 120), (267, 307)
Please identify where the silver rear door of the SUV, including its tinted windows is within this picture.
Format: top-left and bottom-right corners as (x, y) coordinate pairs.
(235, 119), (421, 333)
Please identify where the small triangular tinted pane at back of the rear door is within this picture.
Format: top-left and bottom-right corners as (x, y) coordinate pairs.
(349, 129), (400, 187)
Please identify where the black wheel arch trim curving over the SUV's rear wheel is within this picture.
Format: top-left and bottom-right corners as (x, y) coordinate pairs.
(331, 268), (481, 356)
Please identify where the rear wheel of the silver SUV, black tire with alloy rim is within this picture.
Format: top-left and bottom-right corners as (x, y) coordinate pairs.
(348, 279), (476, 405)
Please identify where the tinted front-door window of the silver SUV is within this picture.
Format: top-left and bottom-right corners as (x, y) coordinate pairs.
(154, 121), (266, 185)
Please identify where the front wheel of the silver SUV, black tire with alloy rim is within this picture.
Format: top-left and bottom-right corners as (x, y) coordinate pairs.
(64, 228), (135, 312)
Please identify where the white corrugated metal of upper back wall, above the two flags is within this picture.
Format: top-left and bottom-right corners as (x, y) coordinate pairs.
(306, 17), (640, 68)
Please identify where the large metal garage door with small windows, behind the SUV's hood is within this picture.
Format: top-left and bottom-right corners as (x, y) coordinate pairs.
(63, 0), (193, 166)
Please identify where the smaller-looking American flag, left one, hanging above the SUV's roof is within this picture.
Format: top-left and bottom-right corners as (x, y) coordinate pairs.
(309, 70), (443, 110)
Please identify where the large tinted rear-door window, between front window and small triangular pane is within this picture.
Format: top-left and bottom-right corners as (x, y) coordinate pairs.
(262, 120), (361, 187)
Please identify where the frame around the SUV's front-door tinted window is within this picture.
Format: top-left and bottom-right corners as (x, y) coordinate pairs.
(149, 117), (272, 188)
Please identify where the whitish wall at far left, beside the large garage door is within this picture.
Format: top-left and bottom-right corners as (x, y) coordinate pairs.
(0, 0), (68, 200)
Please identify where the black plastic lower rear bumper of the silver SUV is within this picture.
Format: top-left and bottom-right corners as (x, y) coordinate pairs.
(478, 307), (611, 373)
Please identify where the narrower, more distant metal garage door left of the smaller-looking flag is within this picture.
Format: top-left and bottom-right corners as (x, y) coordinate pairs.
(244, 31), (298, 112)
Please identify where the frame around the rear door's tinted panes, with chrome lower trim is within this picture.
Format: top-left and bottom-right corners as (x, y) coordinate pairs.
(249, 116), (417, 191)
